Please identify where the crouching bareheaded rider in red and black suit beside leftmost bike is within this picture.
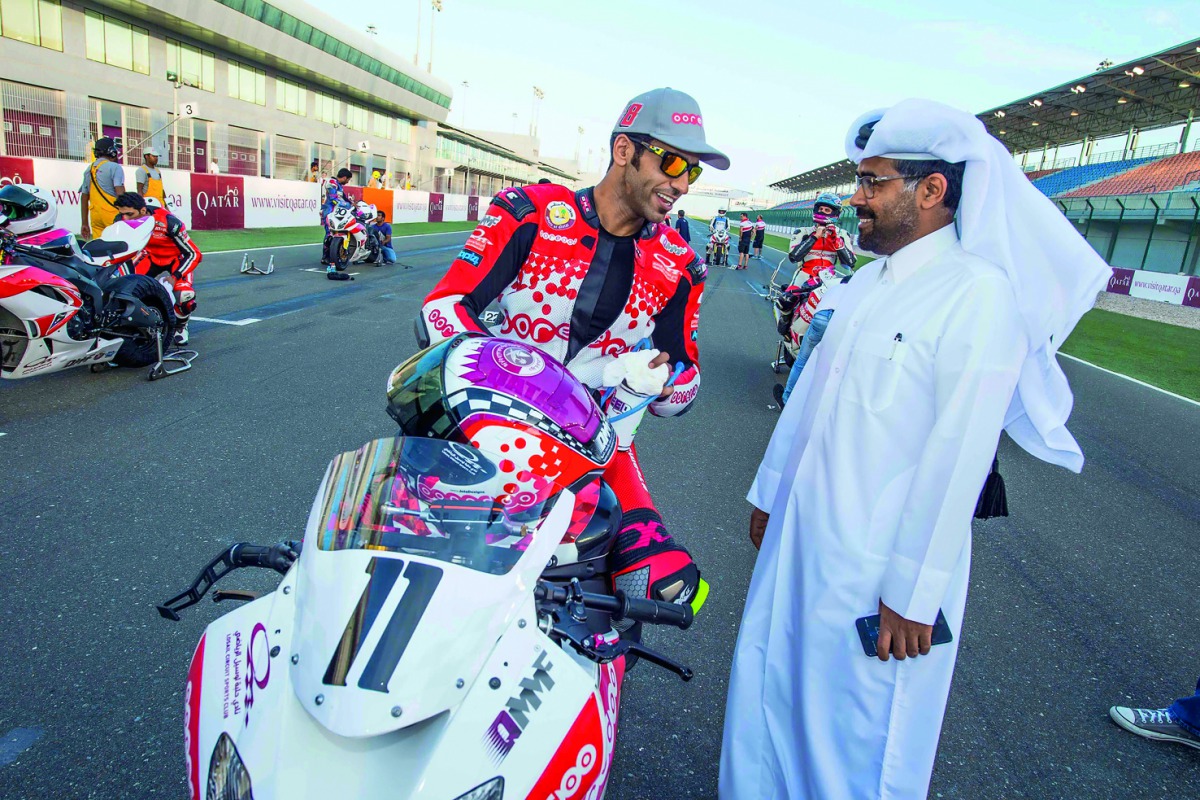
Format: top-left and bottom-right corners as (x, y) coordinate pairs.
(114, 192), (204, 347)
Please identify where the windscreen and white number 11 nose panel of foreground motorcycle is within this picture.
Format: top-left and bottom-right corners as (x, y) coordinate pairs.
(292, 437), (574, 736)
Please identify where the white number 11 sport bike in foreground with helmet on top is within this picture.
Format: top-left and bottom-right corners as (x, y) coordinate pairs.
(158, 333), (692, 800)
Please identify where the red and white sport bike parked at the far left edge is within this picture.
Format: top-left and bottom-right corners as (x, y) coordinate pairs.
(0, 185), (194, 380)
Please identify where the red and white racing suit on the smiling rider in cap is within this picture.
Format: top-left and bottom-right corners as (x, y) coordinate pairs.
(421, 184), (706, 602)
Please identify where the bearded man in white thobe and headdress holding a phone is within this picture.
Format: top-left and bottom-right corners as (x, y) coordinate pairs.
(720, 101), (1109, 800)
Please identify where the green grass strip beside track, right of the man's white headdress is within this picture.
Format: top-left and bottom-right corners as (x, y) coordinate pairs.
(1062, 308), (1200, 401)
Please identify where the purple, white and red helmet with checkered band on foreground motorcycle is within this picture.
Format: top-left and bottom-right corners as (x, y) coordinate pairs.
(388, 332), (617, 493)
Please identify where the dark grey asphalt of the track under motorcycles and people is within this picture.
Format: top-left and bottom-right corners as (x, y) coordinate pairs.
(0, 233), (1200, 800)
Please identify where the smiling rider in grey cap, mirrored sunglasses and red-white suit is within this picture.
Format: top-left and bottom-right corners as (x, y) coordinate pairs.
(420, 89), (730, 607)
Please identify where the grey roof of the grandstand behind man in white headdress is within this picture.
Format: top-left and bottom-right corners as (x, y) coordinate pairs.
(770, 38), (1200, 192)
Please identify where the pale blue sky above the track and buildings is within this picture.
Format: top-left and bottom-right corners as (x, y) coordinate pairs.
(324, 0), (1200, 188)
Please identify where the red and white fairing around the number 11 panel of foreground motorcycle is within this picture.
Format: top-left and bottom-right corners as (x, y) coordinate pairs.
(184, 573), (620, 800)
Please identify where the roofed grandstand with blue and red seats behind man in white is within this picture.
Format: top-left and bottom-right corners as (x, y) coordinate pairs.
(762, 38), (1200, 275)
